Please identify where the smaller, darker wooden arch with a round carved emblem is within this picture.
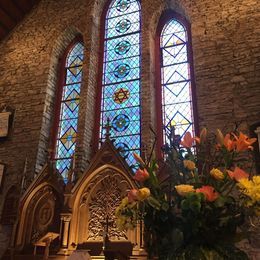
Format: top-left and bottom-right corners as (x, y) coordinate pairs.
(16, 182), (62, 250)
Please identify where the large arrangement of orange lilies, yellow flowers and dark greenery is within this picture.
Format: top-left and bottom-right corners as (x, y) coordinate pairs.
(115, 128), (260, 260)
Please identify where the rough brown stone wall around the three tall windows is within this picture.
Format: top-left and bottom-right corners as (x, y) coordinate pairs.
(0, 0), (260, 256)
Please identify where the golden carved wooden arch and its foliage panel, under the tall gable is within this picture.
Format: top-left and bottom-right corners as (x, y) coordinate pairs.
(69, 164), (138, 249)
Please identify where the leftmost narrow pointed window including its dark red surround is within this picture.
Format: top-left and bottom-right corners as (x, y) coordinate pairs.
(52, 36), (84, 182)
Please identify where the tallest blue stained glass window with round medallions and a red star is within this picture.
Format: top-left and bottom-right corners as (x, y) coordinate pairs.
(100, 0), (141, 169)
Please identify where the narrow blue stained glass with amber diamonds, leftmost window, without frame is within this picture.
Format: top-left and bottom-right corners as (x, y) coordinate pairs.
(55, 42), (84, 182)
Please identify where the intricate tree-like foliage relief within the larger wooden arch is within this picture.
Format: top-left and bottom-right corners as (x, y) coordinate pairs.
(88, 176), (127, 240)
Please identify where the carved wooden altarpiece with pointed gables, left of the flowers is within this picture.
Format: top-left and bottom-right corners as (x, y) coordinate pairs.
(8, 139), (145, 259)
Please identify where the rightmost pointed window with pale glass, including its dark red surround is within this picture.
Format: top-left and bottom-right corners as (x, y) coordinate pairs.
(155, 10), (198, 157)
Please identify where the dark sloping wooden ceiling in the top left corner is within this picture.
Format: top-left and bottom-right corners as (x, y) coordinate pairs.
(0, 0), (39, 41)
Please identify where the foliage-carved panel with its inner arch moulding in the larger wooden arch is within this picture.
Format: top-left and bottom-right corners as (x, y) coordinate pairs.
(79, 169), (130, 241)
